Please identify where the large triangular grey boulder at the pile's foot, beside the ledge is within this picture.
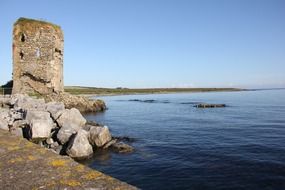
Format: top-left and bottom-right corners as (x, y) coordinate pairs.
(66, 129), (93, 159)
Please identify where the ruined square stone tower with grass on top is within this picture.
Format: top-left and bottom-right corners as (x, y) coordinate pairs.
(13, 18), (64, 95)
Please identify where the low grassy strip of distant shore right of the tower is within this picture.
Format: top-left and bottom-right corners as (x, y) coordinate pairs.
(64, 86), (243, 95)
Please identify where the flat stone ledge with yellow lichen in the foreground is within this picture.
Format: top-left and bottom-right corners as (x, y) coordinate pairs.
(0, 130), (137, 190)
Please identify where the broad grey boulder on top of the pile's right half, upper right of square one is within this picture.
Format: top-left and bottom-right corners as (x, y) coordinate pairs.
(56, 108), (86, 127)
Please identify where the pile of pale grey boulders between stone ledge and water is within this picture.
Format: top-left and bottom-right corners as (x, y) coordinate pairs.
(0, 94), (133, 159)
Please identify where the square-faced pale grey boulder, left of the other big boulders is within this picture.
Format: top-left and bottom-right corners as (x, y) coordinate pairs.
(30, 119), (53, 140)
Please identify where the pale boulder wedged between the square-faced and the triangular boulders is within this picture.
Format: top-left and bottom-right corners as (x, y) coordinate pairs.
(56, 122), (81, 144)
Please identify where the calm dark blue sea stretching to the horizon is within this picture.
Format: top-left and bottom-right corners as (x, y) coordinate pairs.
(82, 90), (285, 190)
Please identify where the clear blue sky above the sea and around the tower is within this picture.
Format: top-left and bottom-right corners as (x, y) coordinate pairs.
(0, 0), (285, 88)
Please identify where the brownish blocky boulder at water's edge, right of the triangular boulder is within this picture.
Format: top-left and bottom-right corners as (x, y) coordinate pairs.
(88, 126), (112, 147)
